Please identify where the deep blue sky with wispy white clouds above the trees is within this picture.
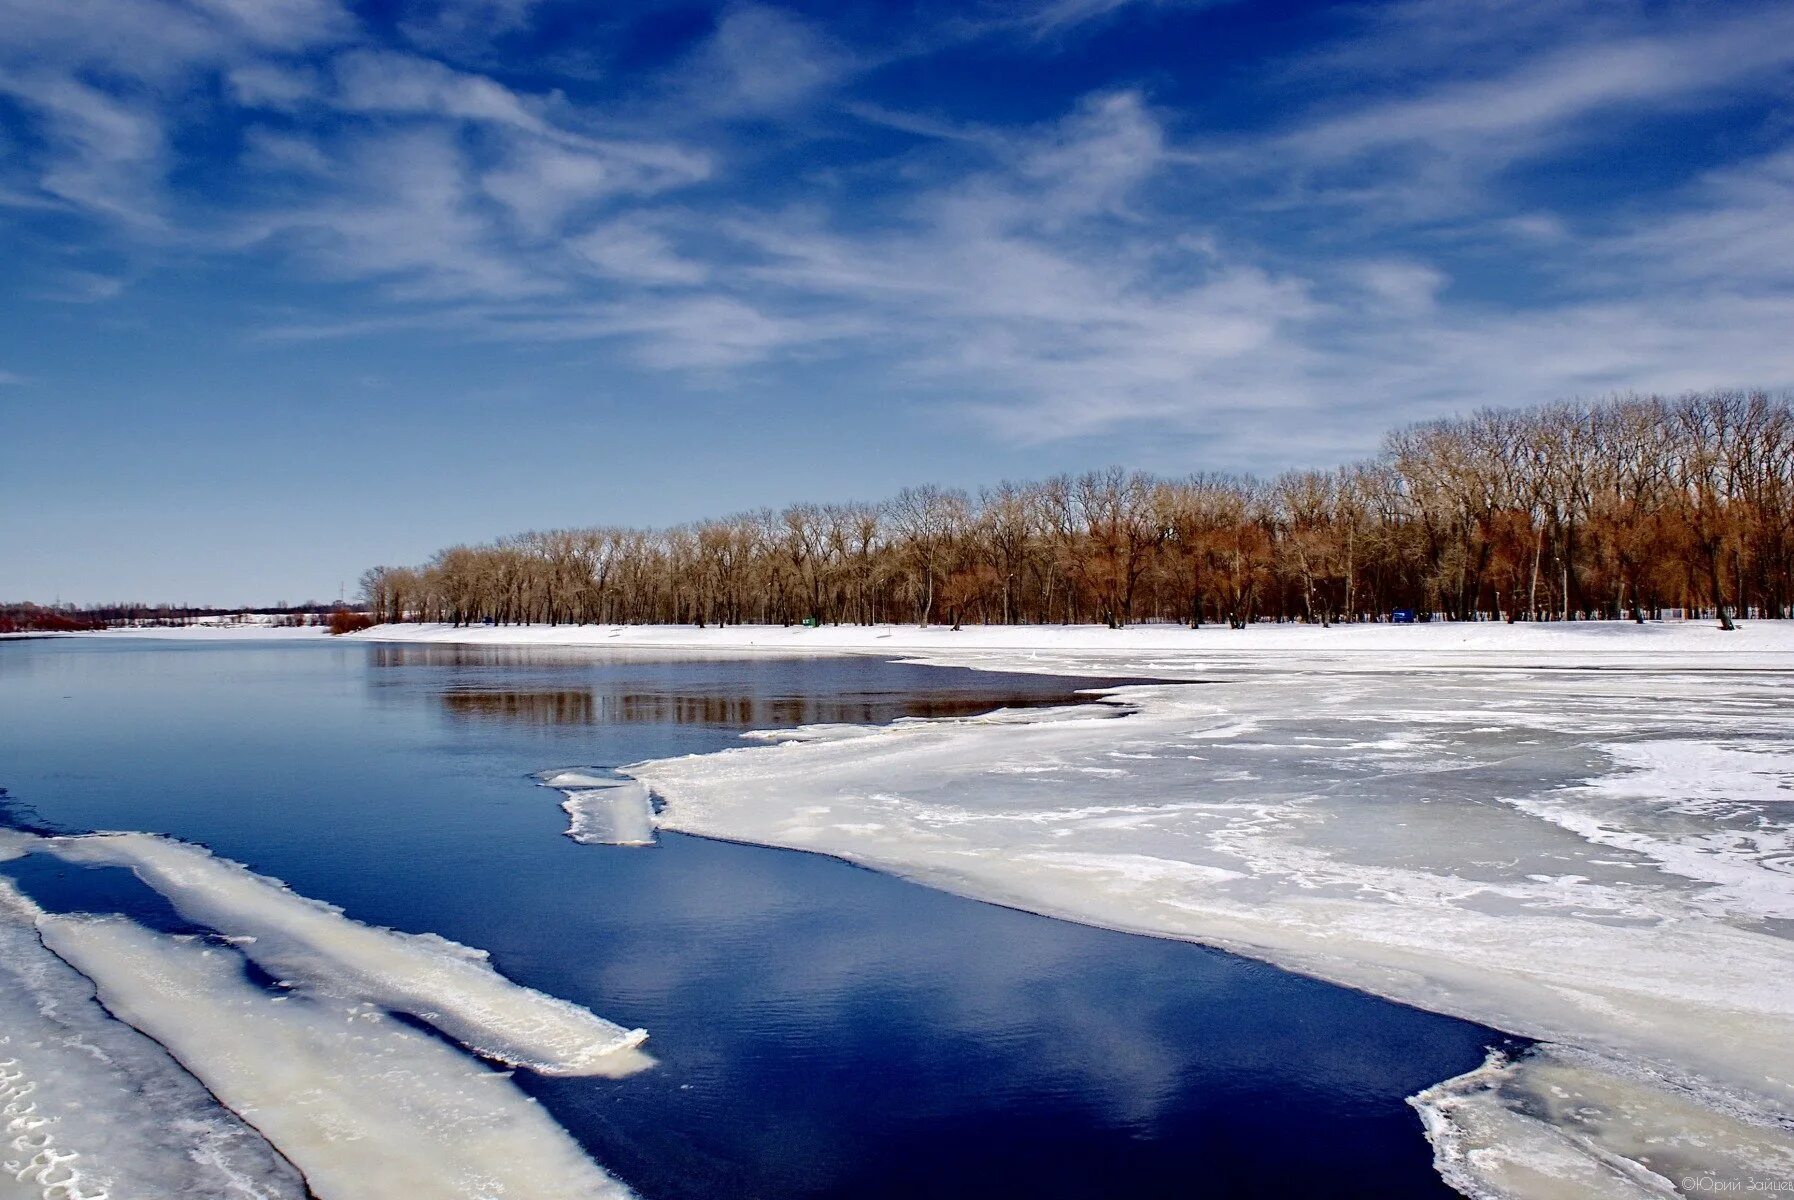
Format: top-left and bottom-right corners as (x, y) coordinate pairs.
(0, 0), (1794, 604)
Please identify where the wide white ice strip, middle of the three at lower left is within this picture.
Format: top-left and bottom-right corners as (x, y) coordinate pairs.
(38, 917), (630, 1200)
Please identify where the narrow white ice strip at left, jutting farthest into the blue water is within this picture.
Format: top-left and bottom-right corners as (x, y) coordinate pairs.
(13, 832), (651, 1076)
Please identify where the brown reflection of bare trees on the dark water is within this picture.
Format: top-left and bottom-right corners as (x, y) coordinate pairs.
(441, 689), (1078, 728)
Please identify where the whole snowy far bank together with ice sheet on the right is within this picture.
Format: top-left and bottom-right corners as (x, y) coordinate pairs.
(362, 622), (1794, 1196)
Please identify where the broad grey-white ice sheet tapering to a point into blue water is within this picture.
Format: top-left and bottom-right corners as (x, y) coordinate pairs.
(626, 655), (1794, 1195)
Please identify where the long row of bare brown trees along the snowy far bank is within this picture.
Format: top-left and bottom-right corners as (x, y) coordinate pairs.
(361, 391), (1794, 628)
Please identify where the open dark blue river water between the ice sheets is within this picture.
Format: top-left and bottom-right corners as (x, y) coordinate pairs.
(0, 640), (1496, 1200)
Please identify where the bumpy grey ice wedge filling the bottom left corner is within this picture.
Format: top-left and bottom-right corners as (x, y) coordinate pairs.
(0, 879), (307, 1200)
